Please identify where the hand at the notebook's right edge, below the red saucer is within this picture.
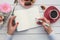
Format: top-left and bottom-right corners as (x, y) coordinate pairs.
(38, 18), (53, 34)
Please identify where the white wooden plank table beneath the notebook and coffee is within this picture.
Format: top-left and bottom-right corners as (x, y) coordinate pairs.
(0, 0), (60, 40)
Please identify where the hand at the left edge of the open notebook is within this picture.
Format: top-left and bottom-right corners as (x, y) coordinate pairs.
(7, 16), (19, 35)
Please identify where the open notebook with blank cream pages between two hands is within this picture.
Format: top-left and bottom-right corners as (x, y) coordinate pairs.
(14, 6), (42, 31)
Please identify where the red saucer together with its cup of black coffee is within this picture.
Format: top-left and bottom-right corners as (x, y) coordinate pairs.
(44, 6), (60, 23)
